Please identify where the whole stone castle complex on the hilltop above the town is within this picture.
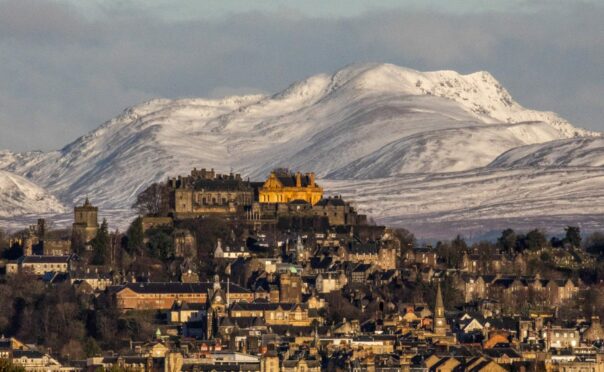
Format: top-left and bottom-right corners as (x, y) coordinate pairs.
(160, 168), (366, 225)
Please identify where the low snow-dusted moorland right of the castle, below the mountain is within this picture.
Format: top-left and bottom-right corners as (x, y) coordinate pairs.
(323, 167), (604, 236)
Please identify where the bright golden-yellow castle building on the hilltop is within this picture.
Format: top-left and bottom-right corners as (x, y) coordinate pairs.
(258, 169), (323, 205)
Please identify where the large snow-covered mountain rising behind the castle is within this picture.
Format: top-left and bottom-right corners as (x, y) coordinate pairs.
(0, 64), (599, 235)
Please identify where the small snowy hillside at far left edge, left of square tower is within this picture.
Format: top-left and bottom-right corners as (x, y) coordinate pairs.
(0, 171), (65, 218)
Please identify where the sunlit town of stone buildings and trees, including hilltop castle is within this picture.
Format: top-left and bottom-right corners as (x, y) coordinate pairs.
(0, 169), (604, 372)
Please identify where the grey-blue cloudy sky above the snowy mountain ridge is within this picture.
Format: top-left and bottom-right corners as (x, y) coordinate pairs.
(0, 0), (604, 151)
